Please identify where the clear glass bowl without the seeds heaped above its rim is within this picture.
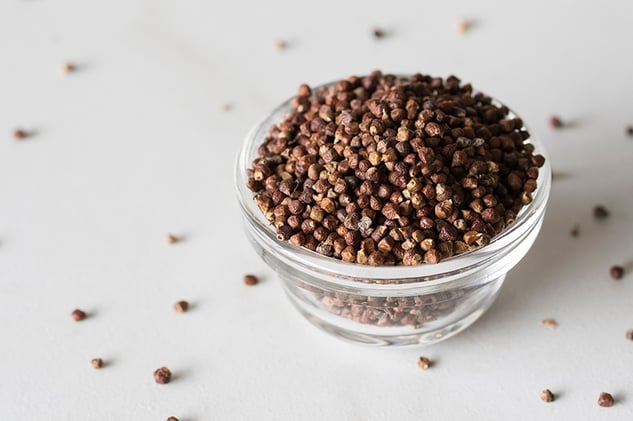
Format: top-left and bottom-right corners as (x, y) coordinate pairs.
(235, 80), (551, 346)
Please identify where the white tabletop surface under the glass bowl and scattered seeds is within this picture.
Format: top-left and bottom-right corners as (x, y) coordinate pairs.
(0, 0), (633, 421)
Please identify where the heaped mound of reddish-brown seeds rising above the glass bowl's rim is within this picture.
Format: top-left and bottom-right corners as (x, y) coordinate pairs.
(247, 71), (545, 266)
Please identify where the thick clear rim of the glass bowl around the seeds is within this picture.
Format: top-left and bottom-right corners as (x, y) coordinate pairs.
(234, 74), (551, 288)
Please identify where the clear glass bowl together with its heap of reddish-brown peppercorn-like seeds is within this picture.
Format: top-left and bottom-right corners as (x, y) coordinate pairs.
(236, 71), (551, 346)
